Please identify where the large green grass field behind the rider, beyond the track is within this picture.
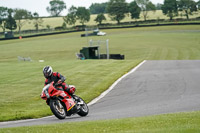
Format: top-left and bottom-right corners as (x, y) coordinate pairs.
(0, 26), (200, 121)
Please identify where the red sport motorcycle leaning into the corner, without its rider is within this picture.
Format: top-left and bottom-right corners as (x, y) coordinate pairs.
(40, 82), (89, 119)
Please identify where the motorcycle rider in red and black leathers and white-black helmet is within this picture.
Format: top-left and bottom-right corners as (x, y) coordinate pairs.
(43, 66), (75, 95)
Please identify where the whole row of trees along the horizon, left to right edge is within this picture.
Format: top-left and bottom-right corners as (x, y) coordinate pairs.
(0, 0), (200, 33)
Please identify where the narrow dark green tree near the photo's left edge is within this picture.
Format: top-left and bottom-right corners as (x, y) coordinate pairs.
(5, 9), (17, 32)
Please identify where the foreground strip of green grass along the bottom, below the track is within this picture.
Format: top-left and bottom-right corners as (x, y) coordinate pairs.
(0, 111), (200, 133)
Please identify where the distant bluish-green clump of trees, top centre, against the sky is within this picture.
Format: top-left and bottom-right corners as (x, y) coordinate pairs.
(89, 2), (108, 14)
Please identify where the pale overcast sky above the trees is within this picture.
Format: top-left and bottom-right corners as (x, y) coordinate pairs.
(0, 0), (196, 16)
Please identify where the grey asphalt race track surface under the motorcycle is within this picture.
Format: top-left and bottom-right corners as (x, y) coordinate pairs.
(0, 60), (200, 128)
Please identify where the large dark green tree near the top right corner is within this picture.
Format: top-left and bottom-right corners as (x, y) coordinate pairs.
(178, 0), (197, 19)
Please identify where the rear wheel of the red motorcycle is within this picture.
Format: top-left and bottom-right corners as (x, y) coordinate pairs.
(77, 97), (89, 116)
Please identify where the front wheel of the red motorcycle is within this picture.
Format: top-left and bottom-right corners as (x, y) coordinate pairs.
(49, 99), (66, 119)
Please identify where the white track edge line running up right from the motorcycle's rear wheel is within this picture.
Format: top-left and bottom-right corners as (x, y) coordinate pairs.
(87, 60), (146, 106)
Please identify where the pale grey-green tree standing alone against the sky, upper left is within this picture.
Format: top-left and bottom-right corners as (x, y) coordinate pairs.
(46, 0), (67, 17)
